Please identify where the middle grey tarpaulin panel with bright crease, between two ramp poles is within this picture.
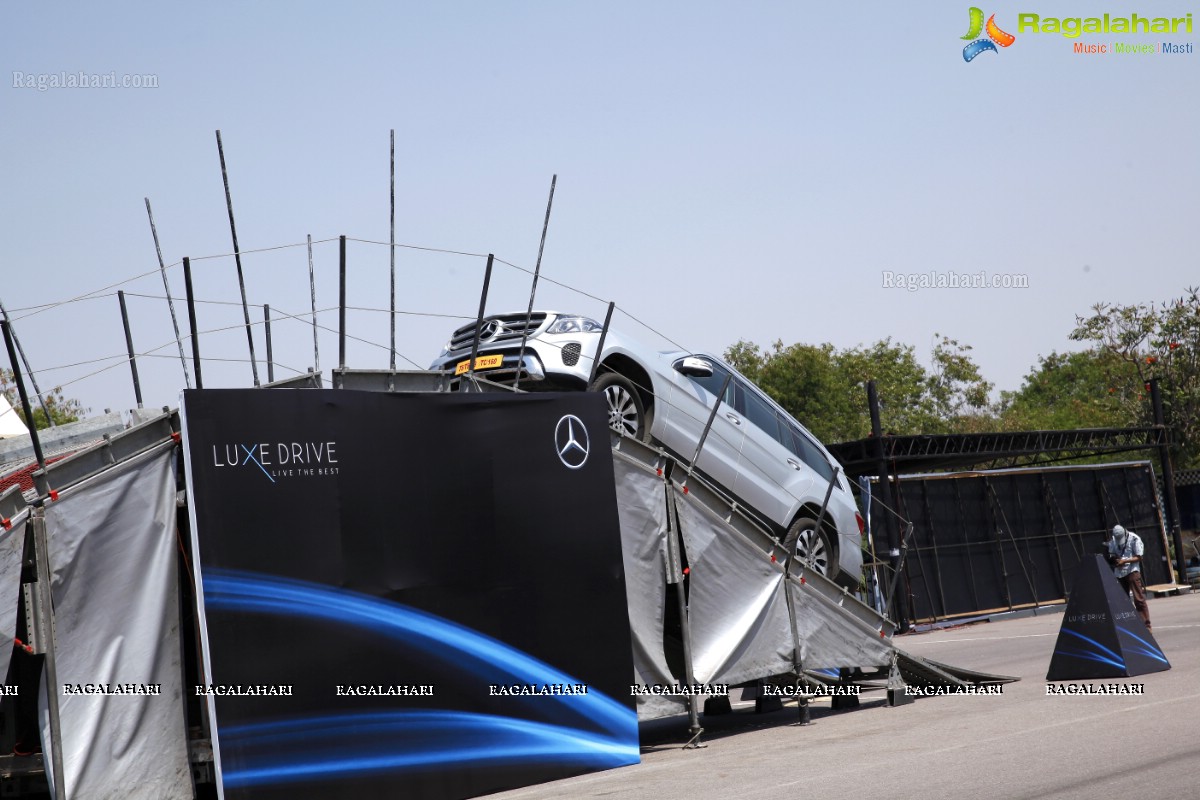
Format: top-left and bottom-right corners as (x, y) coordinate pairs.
(672, 489), (793, 685)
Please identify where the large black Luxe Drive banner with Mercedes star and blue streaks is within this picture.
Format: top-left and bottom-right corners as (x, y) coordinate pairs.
(184, 390), (638, 800)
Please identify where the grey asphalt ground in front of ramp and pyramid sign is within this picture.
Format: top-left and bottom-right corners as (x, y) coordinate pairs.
(488, 594), (1200, 800)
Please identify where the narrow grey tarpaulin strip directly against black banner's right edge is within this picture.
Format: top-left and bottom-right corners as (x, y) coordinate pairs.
(613, 452), (686, 720)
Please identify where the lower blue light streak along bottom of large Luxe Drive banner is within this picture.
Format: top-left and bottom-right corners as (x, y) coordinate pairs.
(221, 711), (638, 789)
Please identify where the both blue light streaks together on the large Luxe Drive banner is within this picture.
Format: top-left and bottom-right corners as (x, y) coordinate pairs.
(204, 570), (640, 787)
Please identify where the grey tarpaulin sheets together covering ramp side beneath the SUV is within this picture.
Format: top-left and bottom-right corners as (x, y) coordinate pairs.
(613, 441), (895, 720)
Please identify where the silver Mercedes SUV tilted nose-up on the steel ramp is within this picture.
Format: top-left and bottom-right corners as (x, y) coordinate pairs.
(430, 311), (863, 585)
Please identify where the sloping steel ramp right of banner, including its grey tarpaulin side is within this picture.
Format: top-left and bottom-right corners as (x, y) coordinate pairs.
(613, 434), (1014, 727)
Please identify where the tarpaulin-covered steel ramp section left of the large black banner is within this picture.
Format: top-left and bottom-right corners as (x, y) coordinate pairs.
(0, 410), (196, 799)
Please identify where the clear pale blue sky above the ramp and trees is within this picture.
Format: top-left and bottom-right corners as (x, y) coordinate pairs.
(0, 0), (1200, 422)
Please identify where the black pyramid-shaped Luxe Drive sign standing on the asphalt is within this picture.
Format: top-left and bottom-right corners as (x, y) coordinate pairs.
(1046, 555), (1171, 680)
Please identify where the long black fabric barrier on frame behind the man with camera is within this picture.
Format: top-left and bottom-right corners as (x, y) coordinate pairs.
(898, 462), (1170, 620)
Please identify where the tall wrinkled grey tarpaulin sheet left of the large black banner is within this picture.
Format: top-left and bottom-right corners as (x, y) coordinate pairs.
(42, 445), (193, 800)
